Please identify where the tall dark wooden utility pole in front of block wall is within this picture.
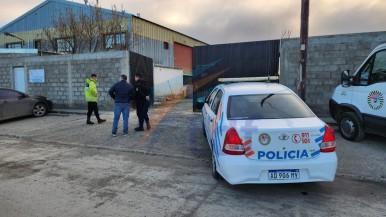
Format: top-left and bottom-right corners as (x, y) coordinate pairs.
(298, 0), (310, 101)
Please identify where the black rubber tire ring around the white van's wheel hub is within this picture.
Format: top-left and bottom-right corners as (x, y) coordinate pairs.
(339, 112), (366, 141)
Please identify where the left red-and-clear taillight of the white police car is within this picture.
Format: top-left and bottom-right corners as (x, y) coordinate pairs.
(222, 128), (244, 155)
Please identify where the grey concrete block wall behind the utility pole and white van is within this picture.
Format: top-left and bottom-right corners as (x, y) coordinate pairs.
(280, 32), (386, 116)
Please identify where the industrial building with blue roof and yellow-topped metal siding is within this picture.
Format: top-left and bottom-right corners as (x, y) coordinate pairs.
(0, 0), (207, 76)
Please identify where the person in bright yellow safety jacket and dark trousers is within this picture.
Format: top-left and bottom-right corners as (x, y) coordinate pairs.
(84, 74), (106, 124)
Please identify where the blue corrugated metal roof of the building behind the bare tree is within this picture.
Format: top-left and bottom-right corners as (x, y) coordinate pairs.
(0, 0), (132, 34)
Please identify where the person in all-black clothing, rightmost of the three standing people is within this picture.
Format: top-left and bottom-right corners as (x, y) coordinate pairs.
(134, 73), (151, 131)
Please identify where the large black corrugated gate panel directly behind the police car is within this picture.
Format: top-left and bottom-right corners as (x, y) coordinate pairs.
(192, 40), (280, 111)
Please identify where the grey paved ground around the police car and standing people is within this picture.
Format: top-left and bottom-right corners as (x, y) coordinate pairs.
(0, 100), (386, 217)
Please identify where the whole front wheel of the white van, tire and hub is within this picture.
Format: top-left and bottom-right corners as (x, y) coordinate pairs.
(339, 112), (365, 141)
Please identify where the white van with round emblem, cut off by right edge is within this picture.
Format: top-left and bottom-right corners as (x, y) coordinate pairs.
(329, 44), (386, 141)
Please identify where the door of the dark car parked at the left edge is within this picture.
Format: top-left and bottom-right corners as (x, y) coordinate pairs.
(0, 89), (32, 119)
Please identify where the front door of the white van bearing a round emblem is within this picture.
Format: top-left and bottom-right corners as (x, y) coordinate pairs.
(352, 50), (386, 130)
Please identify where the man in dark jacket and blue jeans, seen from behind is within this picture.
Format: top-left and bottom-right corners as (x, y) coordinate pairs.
(109, 75), (135, 136)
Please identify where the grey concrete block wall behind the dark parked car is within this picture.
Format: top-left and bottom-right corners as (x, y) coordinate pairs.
(0, 51), (130, 110)
